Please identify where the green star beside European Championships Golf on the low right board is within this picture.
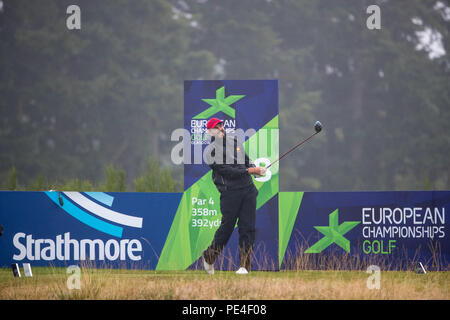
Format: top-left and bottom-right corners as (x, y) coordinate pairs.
(305, 209), (360, 253)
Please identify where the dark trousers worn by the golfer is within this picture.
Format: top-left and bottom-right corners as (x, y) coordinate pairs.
(203, 183), (258, 270)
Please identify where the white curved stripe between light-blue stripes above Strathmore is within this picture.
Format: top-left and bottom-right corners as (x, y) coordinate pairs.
(64, 191), (142, 228)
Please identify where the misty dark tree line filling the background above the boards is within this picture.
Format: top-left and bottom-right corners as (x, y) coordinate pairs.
(0, 0), (450, 192)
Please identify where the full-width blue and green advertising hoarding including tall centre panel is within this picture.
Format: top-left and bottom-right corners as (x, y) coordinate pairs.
(0, 80), (450, 270)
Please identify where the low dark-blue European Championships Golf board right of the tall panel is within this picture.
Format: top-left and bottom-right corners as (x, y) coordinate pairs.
(279, 191), (450, 270)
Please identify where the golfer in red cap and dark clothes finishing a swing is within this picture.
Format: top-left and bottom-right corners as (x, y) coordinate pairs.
(202, 118), (266, 274)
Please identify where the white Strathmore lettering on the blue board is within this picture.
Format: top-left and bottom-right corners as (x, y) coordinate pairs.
(13, 232), (142, 261)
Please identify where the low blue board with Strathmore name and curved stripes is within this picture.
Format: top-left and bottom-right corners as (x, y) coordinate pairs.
(0, 191), (181, 269)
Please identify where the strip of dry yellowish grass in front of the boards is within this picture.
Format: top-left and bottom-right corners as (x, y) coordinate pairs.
(0, 267), (450, 300)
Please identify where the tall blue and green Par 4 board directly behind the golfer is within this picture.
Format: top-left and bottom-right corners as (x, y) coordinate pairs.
(171, 80), (279, 270)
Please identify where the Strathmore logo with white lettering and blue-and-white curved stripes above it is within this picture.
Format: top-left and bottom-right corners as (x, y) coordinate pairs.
(13, 191), (143, 261)
